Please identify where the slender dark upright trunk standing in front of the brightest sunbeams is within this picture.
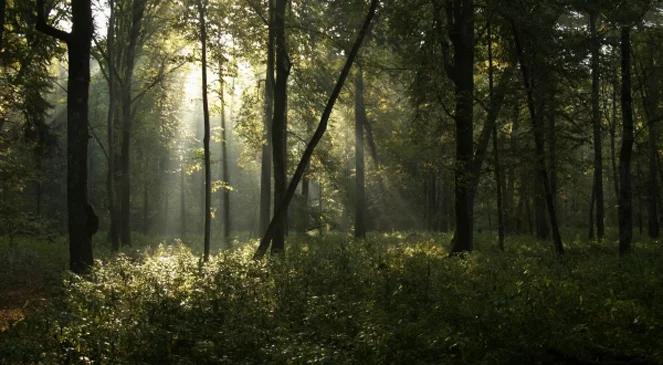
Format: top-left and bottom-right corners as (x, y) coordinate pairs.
(198, 0), (211, 262)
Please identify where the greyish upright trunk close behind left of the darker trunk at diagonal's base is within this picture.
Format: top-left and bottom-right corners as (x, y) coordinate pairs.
(258, 0), (275, 235)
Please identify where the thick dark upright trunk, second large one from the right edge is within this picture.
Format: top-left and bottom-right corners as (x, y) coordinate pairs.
(619, 26), (634, 256)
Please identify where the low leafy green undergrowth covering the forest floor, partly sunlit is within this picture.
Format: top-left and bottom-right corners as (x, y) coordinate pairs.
(0, 233), (663, 364)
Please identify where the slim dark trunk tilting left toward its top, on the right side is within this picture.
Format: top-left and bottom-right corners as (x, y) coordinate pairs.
(512, 24), (564, 255)
